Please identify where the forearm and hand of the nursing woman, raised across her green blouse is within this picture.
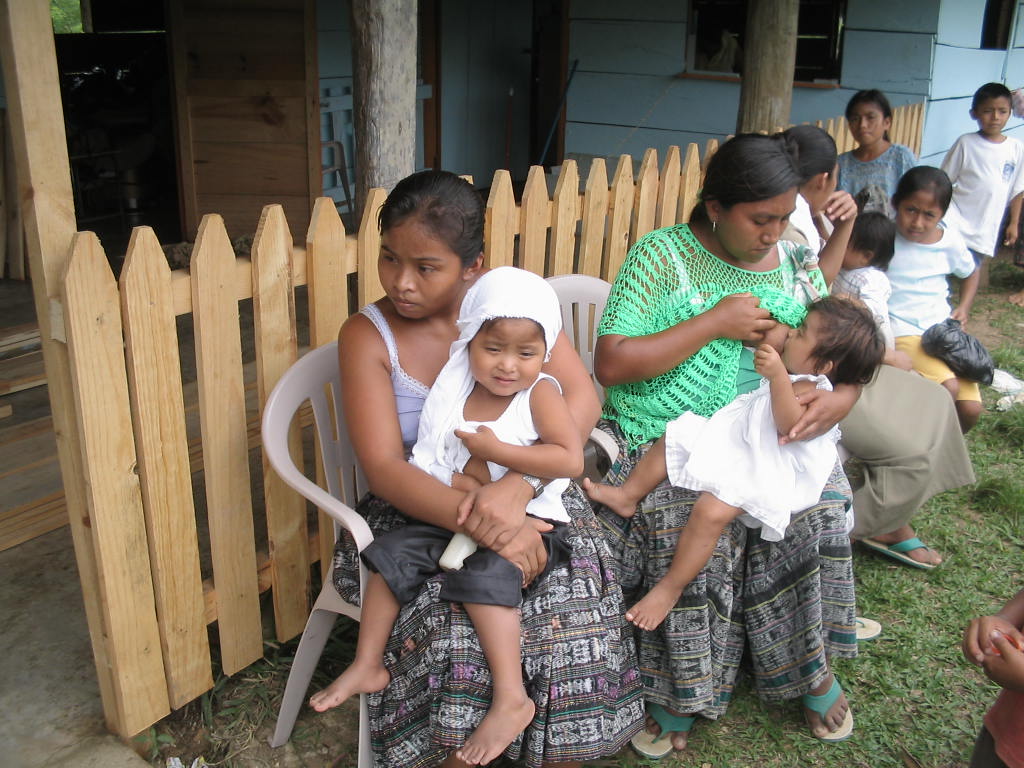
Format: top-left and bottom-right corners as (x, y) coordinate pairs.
(594, 293), (776, 386)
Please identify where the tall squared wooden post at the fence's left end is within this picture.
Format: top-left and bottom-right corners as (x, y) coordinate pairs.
(0, 0), (123, 735)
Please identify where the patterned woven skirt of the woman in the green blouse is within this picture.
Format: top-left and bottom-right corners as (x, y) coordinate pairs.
(597, 421), (857, 719)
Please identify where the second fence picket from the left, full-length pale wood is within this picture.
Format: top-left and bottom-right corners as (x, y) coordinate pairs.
(121, 226), (213, 709)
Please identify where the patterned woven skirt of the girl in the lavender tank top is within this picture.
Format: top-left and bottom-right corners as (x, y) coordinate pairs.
(334, 484), (643, 768)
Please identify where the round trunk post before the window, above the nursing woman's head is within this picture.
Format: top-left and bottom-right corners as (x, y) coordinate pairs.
(736, 0), (800, 133)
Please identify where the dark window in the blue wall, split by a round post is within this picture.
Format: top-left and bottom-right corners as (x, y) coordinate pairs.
(686, 0), (846, 82)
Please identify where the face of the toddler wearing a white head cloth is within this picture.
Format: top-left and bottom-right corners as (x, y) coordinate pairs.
(469, 317), (548, 397)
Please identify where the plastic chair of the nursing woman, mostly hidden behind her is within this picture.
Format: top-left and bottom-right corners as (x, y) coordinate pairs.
(548, 274), (618, 462)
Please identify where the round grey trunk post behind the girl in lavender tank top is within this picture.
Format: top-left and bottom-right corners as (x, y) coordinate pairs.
(351, 0), (417, 215)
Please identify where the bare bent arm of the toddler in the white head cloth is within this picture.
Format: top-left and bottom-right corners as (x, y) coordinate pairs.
(455, 380), (583, 479)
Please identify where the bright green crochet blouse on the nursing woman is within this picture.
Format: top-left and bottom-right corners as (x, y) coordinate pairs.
(598, 224), (828, 450)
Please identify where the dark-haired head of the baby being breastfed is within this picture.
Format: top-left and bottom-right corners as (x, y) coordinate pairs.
(782, 296), (886, 385)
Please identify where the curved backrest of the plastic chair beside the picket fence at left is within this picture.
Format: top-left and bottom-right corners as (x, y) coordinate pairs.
(262, 341), (372, 550)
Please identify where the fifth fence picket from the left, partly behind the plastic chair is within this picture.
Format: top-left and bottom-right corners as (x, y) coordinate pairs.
(306, 198), (348, 580)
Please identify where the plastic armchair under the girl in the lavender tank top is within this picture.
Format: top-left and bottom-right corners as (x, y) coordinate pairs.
(262, 342), (374, 768)
